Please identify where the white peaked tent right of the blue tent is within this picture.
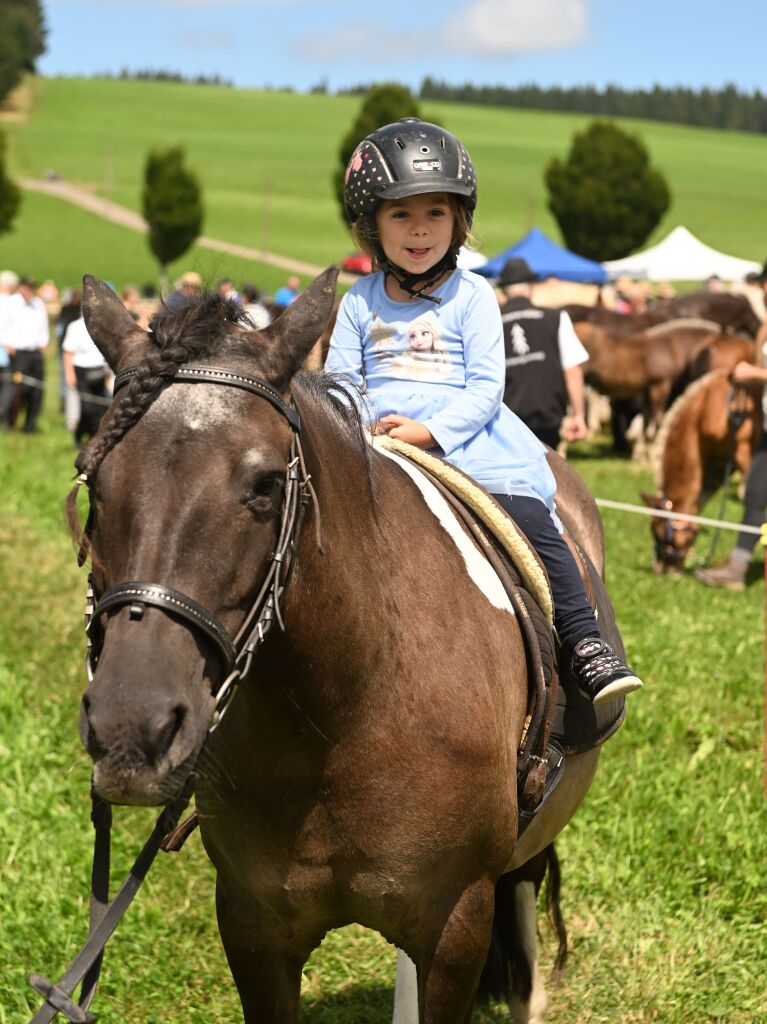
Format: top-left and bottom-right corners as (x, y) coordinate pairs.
(602, 226), (762, 281)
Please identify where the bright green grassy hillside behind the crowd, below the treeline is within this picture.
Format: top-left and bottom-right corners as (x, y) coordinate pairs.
(0, 79), (767, 287)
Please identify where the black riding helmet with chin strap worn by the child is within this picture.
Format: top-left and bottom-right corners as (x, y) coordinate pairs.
(344, 118), (477, 303)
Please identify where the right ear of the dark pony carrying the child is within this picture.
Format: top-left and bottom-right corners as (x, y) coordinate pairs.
(250, 266), (339, 388)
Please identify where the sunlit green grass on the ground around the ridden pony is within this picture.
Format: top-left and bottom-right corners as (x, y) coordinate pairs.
(0, 354), (767, 1024)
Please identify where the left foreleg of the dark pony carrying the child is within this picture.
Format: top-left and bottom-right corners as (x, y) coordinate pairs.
(216, 888), (308, 1024)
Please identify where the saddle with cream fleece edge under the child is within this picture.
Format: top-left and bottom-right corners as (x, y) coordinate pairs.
(374, 436), (626, 835)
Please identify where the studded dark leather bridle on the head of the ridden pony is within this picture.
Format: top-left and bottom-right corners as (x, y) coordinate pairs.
(79, 365), (322, 731)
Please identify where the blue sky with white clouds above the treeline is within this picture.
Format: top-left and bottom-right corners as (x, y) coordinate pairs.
(39, 0), (767, 92)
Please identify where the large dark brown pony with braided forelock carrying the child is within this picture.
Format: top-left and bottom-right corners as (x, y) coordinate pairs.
(70, 270), (622, 1024)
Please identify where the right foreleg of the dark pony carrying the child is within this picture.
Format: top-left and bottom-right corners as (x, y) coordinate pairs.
(418, 879), (495, 1024)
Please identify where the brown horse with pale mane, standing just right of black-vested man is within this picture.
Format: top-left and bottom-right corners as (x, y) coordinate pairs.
(576, 319), (754, 454)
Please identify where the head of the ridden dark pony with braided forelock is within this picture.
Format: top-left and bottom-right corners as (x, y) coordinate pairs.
(70, 268), (337, 804)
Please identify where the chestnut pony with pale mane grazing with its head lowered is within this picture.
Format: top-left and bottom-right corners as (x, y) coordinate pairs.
(642, 370), (762, 573)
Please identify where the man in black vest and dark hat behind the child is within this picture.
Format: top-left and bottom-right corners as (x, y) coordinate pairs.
(498, 258), (589, 449)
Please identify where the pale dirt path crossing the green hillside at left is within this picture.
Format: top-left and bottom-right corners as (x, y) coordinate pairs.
(16, 178), (357, 285)
